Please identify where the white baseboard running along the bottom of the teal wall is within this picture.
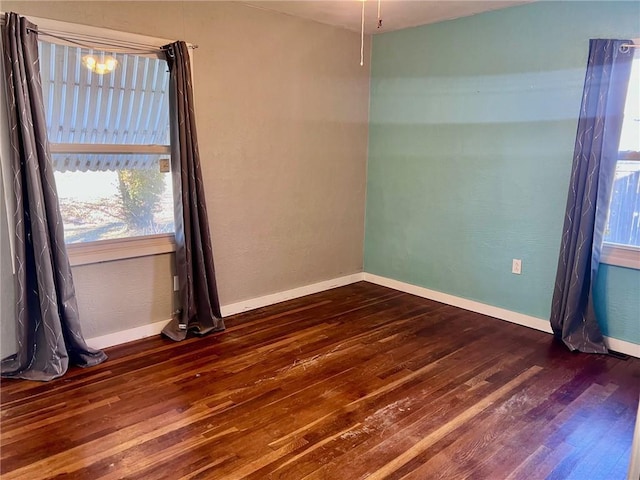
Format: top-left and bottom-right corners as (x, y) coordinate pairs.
(364, 273), (640, 358)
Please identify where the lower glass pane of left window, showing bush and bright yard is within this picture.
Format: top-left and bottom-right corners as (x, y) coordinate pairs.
(54, 154), (174, 243)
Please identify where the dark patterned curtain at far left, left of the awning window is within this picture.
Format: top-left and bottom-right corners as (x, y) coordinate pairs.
(2, 13), (107, 380)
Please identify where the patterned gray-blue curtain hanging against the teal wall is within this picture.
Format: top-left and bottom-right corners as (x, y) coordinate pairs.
(551, 40), (633, 353)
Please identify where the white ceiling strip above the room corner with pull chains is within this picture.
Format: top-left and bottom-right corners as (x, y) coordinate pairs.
(243, 0), (535, 34)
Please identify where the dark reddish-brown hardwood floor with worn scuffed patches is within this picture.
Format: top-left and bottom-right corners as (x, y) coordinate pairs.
(0, 282), (640, 480)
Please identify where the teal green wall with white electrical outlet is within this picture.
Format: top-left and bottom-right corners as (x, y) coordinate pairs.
(365, 2), (640, 343)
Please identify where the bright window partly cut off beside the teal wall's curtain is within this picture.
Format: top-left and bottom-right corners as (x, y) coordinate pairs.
(602, 52), (640, 268)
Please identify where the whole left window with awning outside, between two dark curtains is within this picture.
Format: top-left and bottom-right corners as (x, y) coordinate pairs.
(33, 22), (180, 265)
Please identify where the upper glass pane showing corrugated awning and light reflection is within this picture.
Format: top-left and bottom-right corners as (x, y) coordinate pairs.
(39, 41), (169, 145)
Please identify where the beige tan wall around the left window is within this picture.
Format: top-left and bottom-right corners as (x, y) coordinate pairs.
(2, 0), (369, 344)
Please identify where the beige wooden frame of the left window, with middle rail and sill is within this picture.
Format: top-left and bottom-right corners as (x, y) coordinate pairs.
(2, 12), (188, 266)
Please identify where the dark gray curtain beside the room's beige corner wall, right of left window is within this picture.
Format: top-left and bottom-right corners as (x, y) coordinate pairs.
(162, 42), (224, 340)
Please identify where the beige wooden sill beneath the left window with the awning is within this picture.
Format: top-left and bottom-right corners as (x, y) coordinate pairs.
(67, 234), (176, 266)
